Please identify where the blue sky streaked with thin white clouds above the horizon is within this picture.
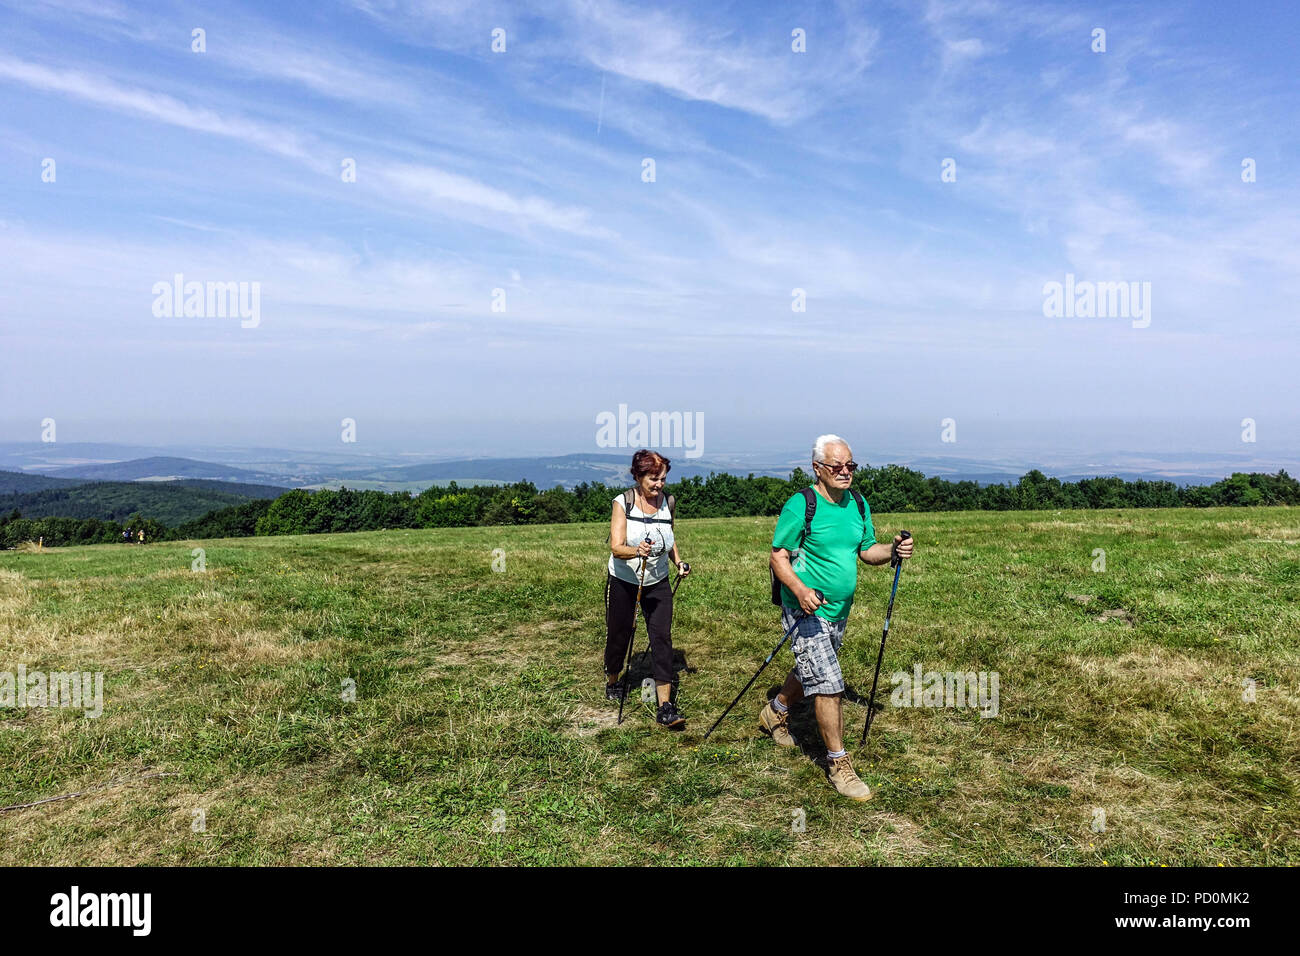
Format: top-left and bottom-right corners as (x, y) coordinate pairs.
(0, 0), (1300, 460)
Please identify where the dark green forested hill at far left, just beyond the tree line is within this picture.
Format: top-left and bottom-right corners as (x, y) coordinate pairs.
(0, 472), (286, 527)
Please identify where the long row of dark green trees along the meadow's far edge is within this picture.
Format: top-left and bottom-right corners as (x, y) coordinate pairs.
(0, 464), (1300, 548)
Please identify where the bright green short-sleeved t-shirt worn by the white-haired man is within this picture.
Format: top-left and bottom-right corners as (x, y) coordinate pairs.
(772, 490), (876, 620)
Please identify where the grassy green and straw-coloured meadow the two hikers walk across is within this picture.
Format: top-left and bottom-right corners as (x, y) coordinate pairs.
(0, 507), (1300, 866)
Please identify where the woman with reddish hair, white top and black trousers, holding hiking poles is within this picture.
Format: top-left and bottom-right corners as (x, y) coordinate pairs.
(605, 449), (690, 730)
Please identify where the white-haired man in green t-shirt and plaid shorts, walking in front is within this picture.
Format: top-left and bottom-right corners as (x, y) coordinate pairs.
(758, 434), (913, 800)
